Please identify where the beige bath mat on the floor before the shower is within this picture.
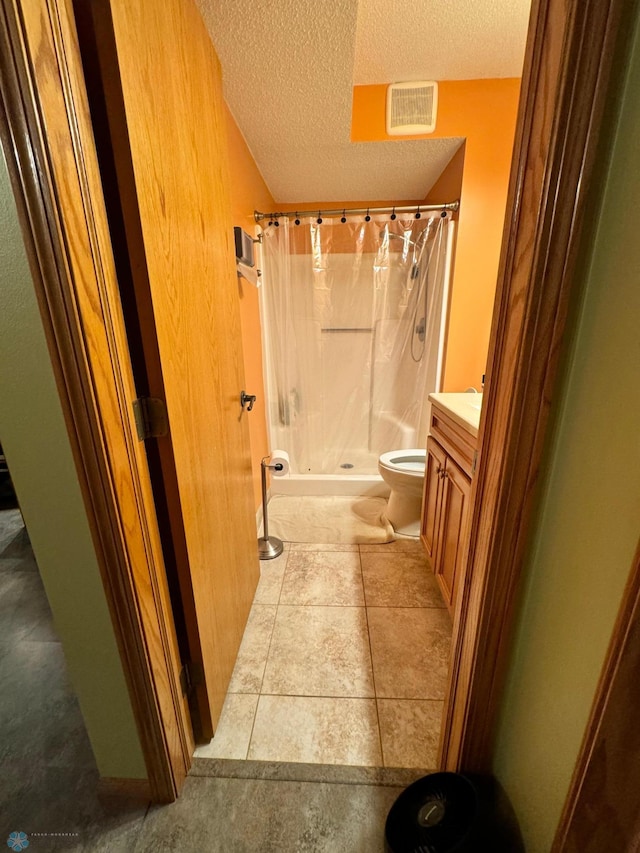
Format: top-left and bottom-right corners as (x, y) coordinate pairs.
(269, 495), (395, 545)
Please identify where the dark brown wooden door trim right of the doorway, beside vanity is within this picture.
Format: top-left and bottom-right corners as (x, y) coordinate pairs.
(440, 0), (630, 772)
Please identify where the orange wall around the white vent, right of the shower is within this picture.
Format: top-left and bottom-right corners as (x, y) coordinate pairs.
(351, 79), (520, 391)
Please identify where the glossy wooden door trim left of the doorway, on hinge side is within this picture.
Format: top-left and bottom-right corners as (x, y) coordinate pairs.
(0, 0), (193, 802)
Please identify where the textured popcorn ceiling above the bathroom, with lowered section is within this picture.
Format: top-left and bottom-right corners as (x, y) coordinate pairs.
(197, 0), (529, 203)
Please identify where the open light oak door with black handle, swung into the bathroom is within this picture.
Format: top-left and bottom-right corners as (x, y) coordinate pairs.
(75, 0), (259, 739)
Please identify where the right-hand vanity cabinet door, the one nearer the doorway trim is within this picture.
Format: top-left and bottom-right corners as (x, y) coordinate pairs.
(435, 458), (471, 611)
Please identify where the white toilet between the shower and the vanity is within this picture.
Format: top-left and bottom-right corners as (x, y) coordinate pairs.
(378, 448), (427, 536)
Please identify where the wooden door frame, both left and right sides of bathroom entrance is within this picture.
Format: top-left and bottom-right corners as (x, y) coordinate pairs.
(0, 0), (631, 801)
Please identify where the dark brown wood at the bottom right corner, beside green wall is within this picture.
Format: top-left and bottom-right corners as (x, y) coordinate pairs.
(551, 542), (640, 853)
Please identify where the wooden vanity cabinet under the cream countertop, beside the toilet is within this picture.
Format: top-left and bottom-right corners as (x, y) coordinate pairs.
(420, 407), (475, 613)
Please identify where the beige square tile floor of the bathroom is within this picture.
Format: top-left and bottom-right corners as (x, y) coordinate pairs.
(196, 539), (451, 769)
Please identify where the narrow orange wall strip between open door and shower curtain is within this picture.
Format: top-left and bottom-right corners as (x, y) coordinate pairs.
(227, 104), (274, 509)
